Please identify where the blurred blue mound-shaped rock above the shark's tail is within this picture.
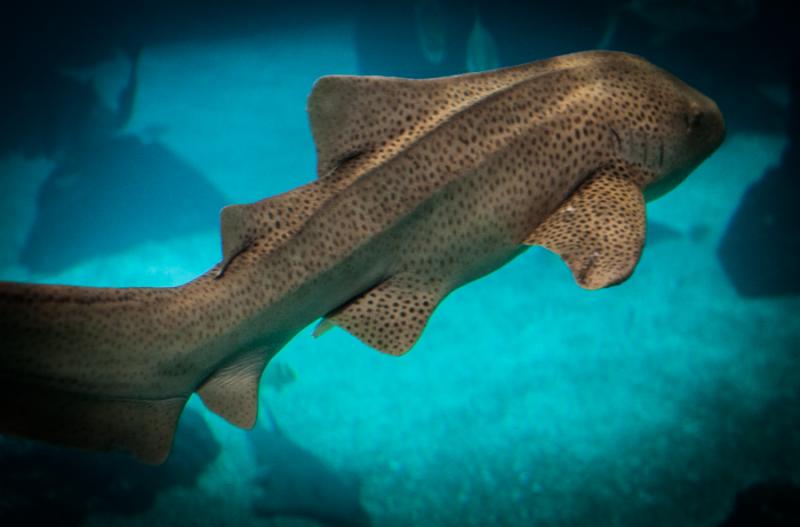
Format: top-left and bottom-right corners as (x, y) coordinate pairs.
(20, 136), (226, 273)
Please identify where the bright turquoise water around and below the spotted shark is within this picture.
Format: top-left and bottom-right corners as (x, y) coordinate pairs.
(0, 2), (800, 526)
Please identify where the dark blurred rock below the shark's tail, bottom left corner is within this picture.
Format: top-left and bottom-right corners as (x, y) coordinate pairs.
(0, 409), (220, 527)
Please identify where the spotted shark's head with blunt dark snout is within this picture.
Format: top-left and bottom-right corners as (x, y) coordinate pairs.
(606, 54), (725, 201)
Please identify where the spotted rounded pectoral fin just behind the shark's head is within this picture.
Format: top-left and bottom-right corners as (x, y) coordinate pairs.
(523, 165), (645, 289)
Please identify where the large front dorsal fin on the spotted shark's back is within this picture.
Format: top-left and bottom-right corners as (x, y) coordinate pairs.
(308, 52), (616, 178)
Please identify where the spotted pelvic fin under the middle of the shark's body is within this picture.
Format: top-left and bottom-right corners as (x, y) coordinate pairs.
(314, 275), (444, 355)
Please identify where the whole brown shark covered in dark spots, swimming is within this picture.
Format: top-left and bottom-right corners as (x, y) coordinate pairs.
(0, 52), (724, 463)
